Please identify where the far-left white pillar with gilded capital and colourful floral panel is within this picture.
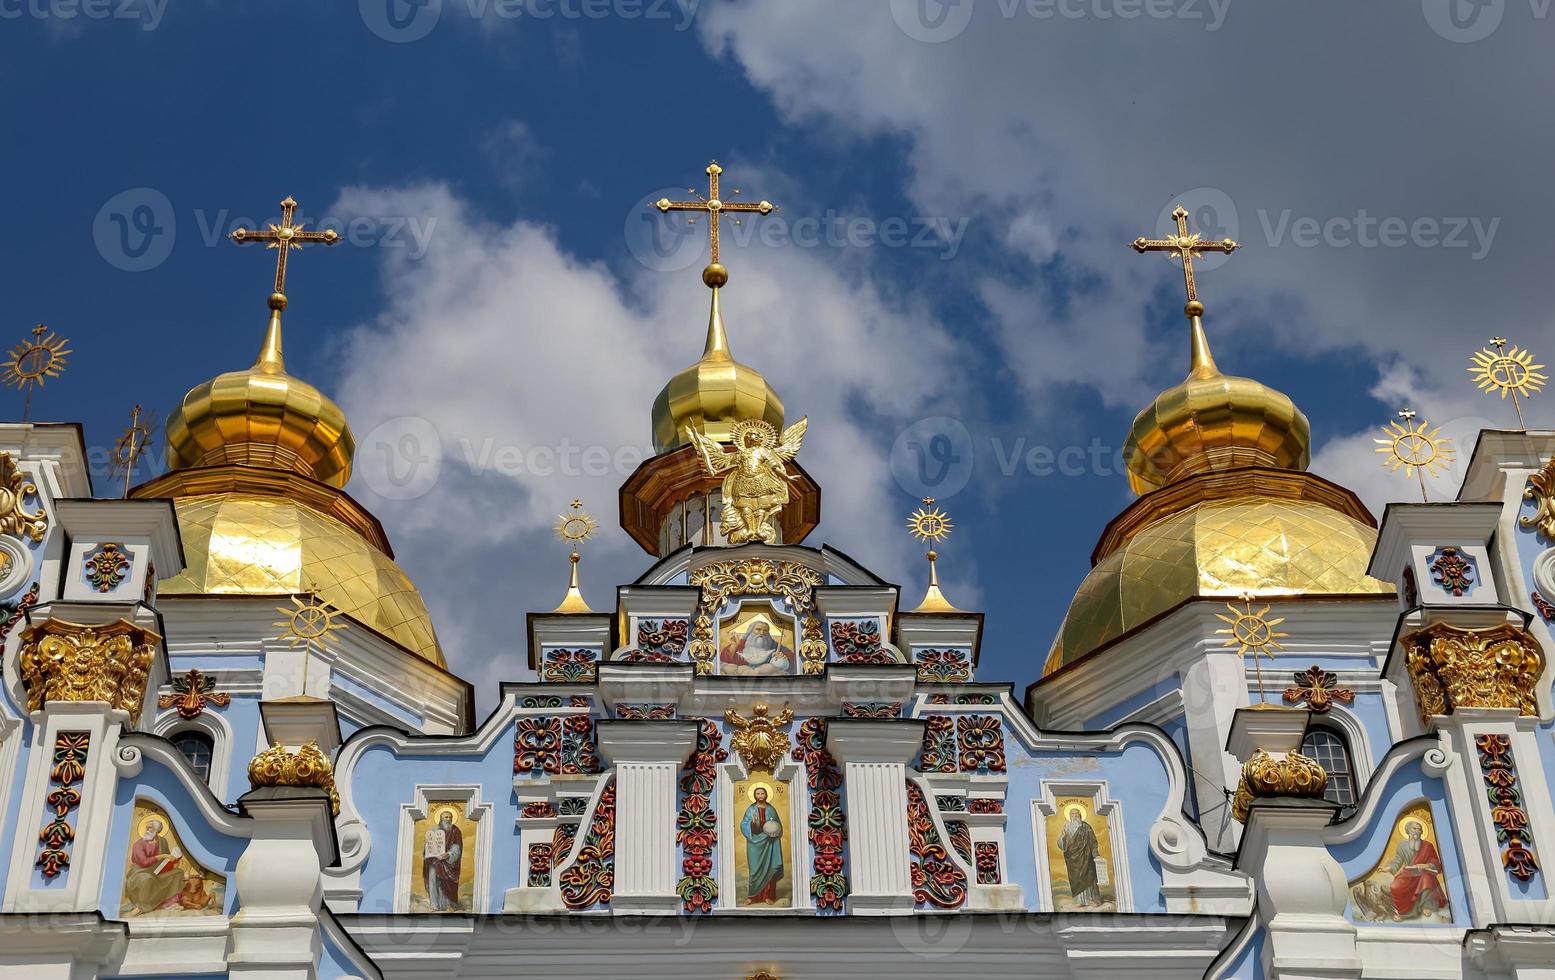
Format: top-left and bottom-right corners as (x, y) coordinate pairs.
(5, 619), (162, 912)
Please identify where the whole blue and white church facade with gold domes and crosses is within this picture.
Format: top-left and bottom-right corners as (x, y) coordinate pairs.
(0, 178), (1555, 980)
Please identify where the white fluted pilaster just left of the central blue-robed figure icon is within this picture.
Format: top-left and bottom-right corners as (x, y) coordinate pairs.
(596, 720), (697, 915)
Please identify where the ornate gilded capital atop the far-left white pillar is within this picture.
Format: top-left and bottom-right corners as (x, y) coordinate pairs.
(20, 619), (162, 723)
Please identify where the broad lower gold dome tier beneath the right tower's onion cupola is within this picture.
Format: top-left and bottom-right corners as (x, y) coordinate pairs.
(1043, 468), (1393, 674)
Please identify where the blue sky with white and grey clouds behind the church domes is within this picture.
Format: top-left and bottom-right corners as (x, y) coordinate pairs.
(0, 0), (1555, 703)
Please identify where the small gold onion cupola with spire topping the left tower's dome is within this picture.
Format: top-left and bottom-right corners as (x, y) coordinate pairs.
(166, 292), (356, 487)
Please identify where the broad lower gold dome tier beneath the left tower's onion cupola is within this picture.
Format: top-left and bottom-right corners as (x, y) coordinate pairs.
(159, 493), (446, 667)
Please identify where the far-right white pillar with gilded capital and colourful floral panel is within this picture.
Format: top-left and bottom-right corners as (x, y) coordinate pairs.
(1389, 622), (1555, 927)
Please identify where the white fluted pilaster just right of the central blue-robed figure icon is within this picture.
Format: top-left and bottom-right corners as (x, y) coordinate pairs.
(826, 719), (924, 915)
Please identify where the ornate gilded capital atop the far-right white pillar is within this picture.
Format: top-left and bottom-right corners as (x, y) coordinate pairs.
(1404, 622), (1544, 723)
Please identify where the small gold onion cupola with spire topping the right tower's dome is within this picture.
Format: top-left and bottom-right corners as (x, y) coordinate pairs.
(1124, 316), (1312, 493)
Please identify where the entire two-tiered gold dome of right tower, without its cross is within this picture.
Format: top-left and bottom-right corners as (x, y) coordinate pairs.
(1045, 309), (1393, 674)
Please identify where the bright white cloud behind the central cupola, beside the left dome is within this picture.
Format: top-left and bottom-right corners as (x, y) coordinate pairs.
(334, 185), (975, 697)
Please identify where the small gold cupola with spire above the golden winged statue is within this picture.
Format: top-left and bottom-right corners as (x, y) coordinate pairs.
(653, 264), (782, 453)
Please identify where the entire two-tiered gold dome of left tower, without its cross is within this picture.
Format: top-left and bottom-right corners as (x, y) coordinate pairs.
(144, 292), (446, 667)
